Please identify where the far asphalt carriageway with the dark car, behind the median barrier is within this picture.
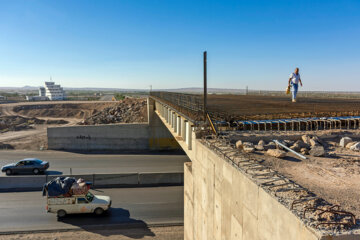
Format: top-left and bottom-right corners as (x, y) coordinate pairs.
(0, 150), (190, 175)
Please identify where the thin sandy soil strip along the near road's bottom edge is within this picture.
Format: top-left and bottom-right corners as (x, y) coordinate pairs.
(0, 226), (184, 240)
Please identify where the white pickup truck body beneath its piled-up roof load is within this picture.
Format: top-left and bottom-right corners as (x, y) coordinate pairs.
(46, 192), (111, 218)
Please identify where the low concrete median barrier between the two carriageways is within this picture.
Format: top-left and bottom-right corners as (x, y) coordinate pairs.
(0, 172), (184, 191)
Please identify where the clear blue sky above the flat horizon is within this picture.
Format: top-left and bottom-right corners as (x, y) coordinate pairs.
(0, 0), (360, 91)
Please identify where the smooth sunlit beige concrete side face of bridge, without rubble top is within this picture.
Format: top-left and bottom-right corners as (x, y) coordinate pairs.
(150, 97), (360, 240)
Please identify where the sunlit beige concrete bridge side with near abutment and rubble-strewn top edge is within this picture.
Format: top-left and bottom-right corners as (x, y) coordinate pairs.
(148, 97), (360, 240)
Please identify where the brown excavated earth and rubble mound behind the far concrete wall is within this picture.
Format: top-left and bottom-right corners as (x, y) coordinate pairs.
(0, 98), (147, 150)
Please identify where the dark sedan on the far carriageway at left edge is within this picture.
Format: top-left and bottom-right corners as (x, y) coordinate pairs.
(1, 158), (49, 175)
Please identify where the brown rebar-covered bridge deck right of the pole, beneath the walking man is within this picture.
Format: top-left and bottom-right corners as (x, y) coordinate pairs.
(208, 94), (360, 120)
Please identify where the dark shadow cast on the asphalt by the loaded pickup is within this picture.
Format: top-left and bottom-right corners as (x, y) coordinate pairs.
(58, 208), (155, 239)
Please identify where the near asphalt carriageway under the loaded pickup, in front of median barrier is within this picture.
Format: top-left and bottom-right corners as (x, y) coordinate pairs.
(0, 187), (184, 234)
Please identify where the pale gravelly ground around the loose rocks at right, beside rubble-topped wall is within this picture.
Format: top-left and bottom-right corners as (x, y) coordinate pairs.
(233, 130), (360, 219)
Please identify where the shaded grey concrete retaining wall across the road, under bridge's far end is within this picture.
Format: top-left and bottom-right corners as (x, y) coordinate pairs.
(47, 100), (181, 151)
